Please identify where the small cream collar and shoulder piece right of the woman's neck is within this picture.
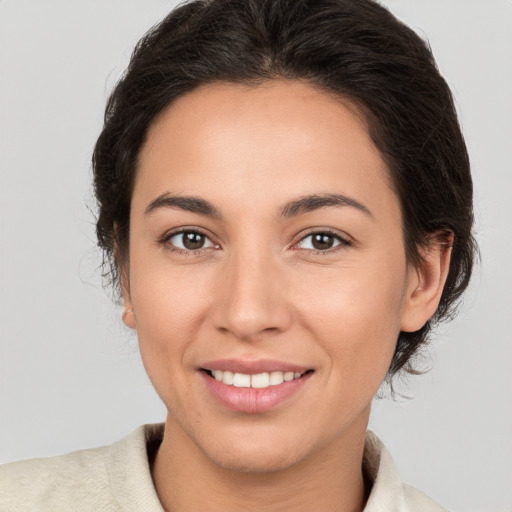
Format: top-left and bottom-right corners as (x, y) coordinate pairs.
(363, 432), (447, 512)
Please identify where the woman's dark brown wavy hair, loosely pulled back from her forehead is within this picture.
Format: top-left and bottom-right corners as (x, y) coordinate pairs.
(93, 0), (476, 376)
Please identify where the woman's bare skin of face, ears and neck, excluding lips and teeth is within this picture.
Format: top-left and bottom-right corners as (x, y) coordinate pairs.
(120, 80), (450, 512)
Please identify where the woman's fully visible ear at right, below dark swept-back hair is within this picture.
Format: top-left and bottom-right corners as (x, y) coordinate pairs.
(400, 231), (453, 332)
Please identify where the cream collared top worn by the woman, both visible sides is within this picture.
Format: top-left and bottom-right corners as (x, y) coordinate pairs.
(0, 424), (446, 512)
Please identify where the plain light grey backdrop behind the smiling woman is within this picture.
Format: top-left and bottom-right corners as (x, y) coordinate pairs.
(0, 0), (512, 512)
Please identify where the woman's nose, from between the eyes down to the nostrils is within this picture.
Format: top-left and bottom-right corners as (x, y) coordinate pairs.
(213, 248), (292, 341)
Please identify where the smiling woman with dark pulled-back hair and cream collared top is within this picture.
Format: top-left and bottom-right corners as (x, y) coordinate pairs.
(0, 0), (474, 511)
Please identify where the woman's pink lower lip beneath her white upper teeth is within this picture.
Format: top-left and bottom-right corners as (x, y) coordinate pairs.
(200, 371), (311, 414)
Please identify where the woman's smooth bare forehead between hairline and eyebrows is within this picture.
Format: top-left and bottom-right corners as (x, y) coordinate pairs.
(134, 80), (395, 219)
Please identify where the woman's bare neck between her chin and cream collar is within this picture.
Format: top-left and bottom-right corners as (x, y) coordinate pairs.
(153, 411), (369, 512)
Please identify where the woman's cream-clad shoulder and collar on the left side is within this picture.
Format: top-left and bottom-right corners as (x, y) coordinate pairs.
(0, 425), (164, 512)
